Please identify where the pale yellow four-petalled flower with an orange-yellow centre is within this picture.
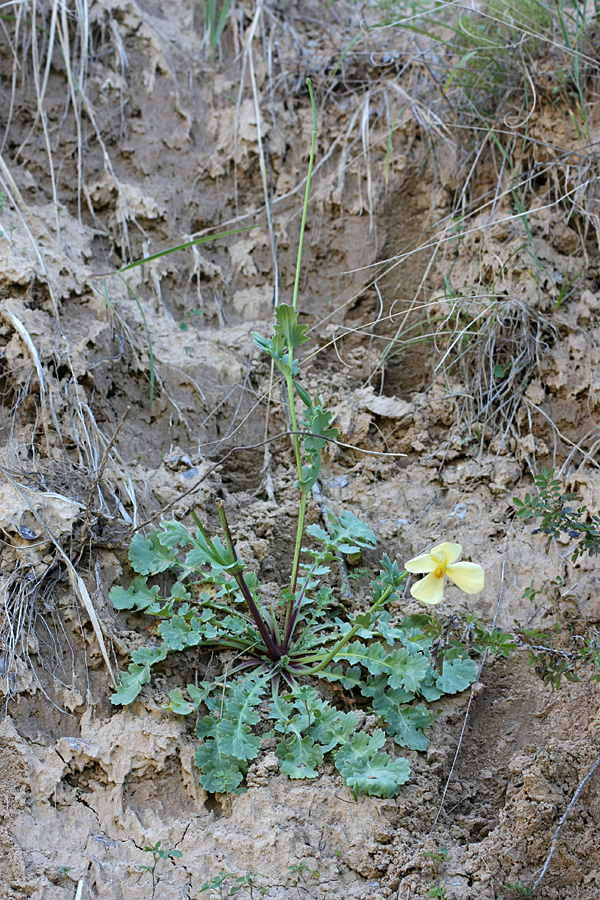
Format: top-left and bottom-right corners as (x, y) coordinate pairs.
(404, 542), (483, 603)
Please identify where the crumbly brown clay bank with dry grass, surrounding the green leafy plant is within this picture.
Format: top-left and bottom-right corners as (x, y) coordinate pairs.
(0, 0), (600, 900)
